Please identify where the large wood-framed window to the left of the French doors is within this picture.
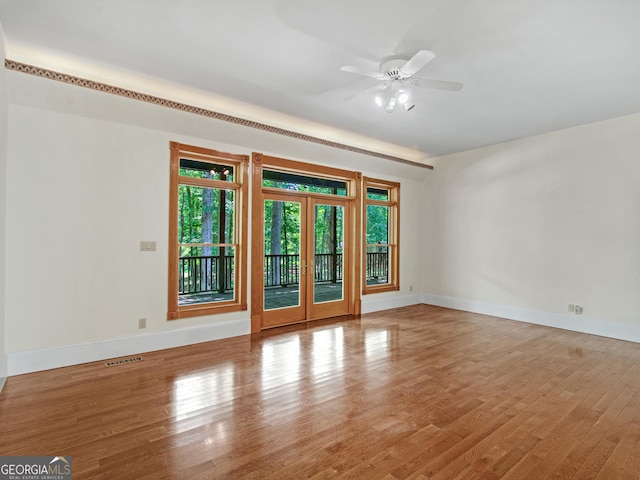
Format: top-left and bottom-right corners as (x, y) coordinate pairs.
(167, 142), (249, 320)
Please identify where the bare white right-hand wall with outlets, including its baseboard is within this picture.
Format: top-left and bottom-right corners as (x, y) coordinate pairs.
(423, 115), (640, 341)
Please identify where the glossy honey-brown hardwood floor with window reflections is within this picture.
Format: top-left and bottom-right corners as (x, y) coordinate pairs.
(0, 305), (640, 480)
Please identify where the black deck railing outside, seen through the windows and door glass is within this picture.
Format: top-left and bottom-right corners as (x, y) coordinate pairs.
(178, 252), (389, 295)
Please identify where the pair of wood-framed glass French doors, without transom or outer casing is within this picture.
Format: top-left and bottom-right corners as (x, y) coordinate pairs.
(261, 192), (353, 328)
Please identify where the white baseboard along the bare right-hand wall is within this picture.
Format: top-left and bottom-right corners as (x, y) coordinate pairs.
(422, 293), (640, 343)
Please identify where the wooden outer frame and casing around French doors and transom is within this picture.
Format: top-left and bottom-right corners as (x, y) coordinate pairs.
(251, 152), (362, 333)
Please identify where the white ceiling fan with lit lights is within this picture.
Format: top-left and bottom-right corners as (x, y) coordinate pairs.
(340, 50), (462, 113)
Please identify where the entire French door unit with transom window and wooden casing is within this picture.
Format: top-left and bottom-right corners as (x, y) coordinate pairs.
(251, 153), (362, 333)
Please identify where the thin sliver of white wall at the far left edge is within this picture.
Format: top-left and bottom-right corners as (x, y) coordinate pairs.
(0, 25), (7, 392)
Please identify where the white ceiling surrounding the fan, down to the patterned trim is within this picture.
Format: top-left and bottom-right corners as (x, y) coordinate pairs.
(0, 0), (640, 158)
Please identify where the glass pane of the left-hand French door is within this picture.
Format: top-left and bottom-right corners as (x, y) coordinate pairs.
(264, 199), (302, 310)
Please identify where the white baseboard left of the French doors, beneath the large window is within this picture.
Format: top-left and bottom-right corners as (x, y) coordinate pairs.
(6, 319), (250, 376)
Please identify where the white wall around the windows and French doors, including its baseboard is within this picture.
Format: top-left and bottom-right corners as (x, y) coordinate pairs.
(6, 72), (428, 375)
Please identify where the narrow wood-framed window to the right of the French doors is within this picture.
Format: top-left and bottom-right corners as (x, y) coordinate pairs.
(362, 177), (400, 294)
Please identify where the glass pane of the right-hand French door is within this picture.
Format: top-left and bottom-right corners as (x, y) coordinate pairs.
(313, 203), (344, 303)
